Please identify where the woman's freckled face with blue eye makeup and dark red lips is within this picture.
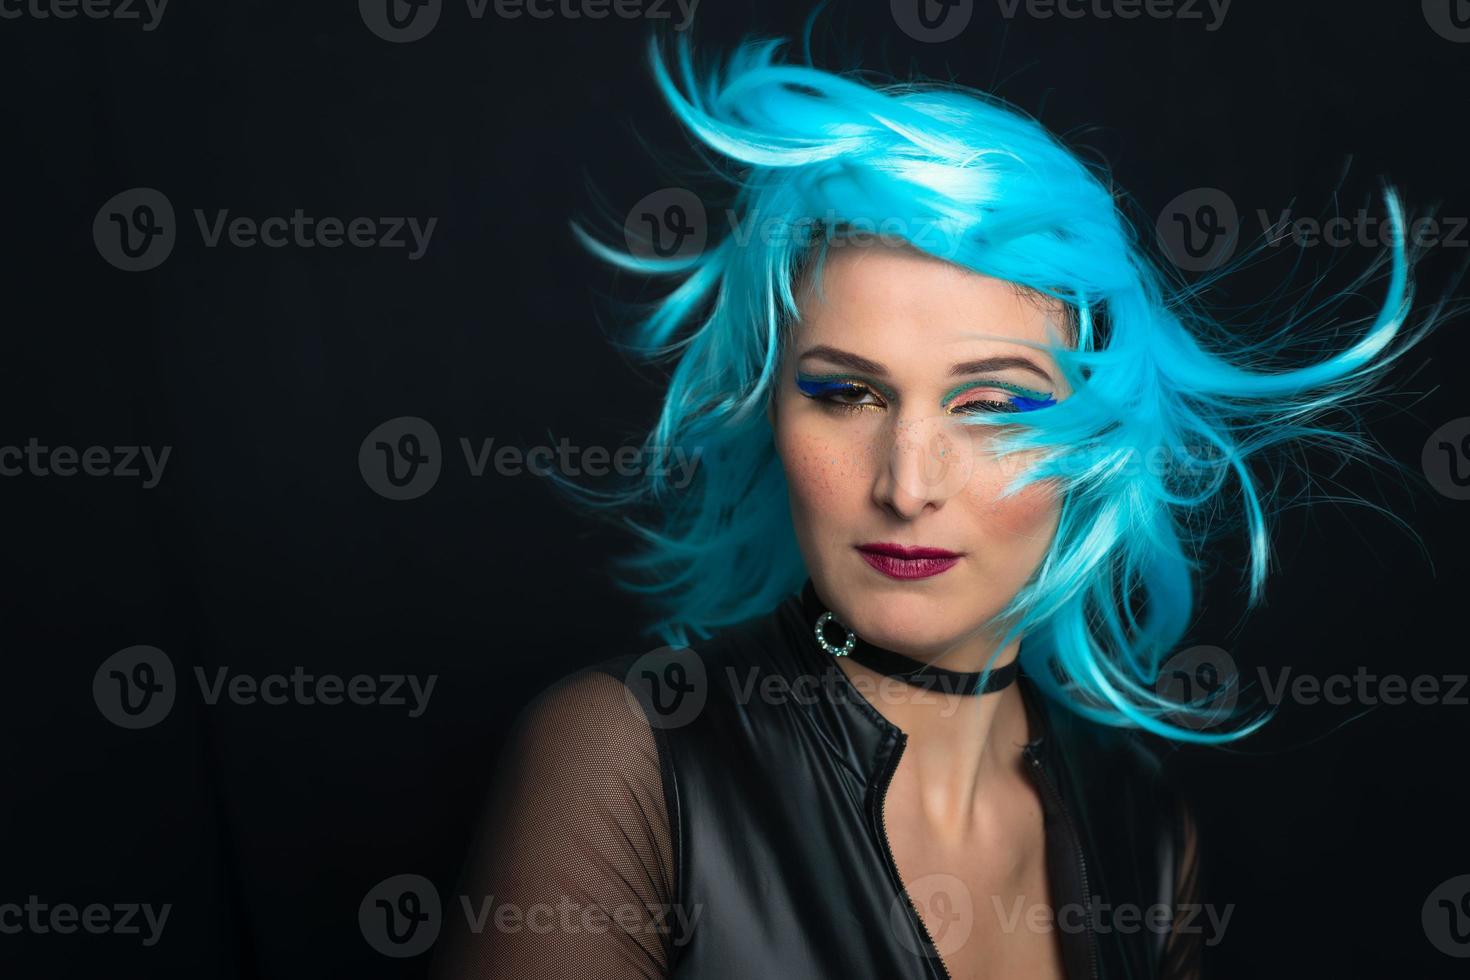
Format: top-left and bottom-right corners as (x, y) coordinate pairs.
(770, 245), (1067, 667)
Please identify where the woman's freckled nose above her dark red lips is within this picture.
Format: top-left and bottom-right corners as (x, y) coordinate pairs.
(873, 416), (975, 520)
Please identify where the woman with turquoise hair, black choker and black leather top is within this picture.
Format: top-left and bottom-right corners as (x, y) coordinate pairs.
(445, 30), (1427, 980)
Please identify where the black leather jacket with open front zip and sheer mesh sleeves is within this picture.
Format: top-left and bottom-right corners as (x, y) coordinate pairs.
(442, 597), (1200, 980)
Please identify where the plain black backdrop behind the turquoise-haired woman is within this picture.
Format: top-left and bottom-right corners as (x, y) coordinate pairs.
(0, 0), (1470, 977)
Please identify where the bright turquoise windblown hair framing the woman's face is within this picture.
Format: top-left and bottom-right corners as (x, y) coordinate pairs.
(575, 41), (1429, 742)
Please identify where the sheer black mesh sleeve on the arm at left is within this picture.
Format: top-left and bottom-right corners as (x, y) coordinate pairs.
(435, 670), (676, 980)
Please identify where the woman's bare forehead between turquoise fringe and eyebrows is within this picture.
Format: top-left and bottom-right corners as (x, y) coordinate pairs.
(797, 242), (1066, 361)
